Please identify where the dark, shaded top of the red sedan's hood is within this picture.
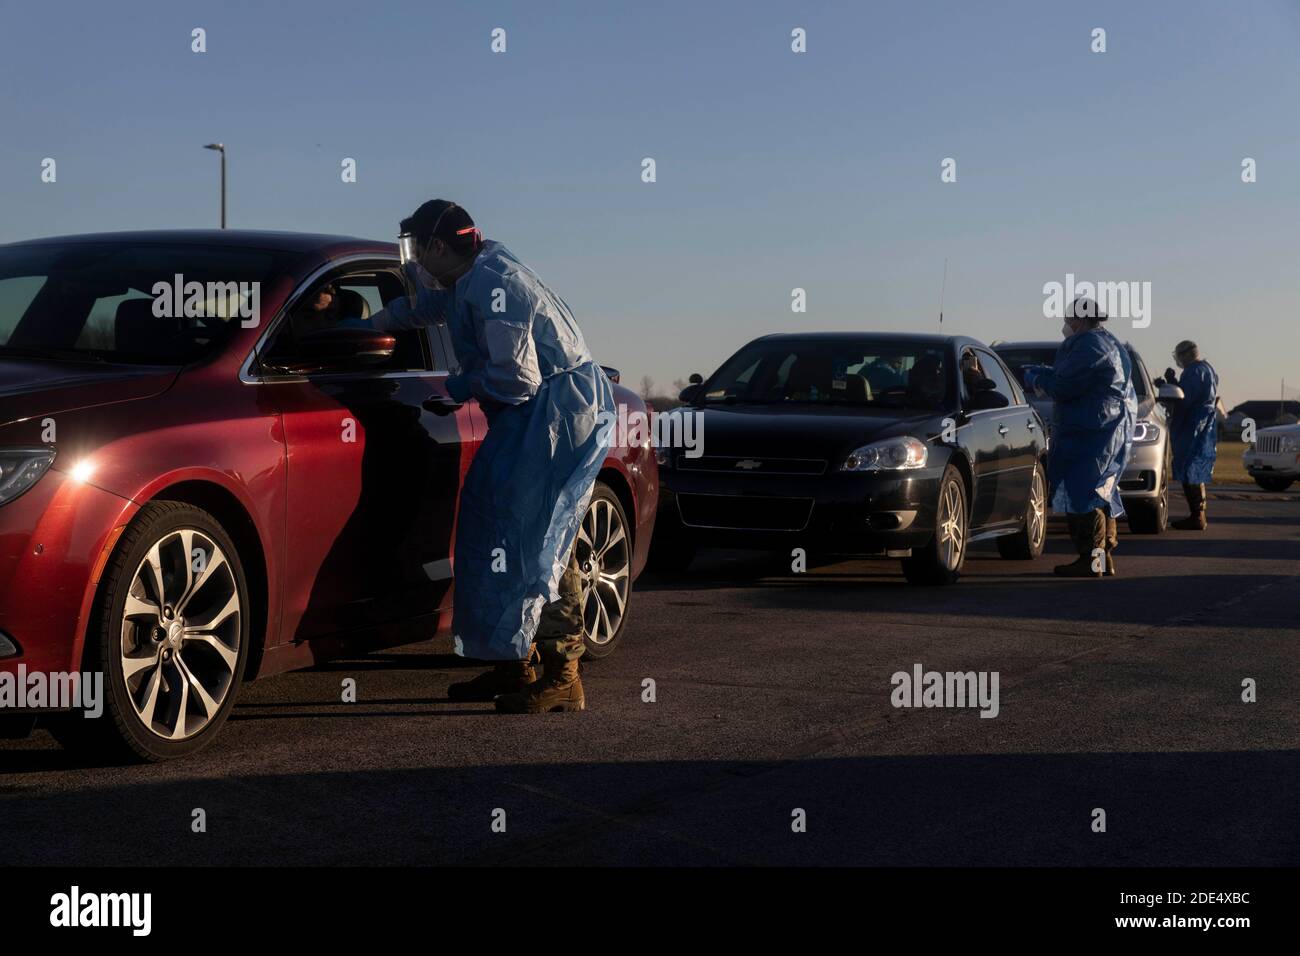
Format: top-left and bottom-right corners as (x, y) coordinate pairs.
(0, 359), (177, 425)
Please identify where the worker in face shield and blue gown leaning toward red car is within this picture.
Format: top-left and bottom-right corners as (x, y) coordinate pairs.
(371, 199), (615, 713)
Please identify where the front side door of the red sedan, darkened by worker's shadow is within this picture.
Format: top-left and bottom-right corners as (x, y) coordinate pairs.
(263, 267), (473, 640)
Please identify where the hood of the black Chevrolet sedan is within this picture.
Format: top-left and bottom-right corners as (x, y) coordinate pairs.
(676, 405), (940, 460)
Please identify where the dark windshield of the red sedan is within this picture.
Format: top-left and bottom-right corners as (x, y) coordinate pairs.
(0, 242), (295, 365)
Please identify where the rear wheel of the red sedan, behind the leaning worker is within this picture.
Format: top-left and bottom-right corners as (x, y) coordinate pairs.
(575, 481), (632, 661)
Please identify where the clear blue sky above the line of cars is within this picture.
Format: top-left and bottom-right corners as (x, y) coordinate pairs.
(0, 0), (1300, 405)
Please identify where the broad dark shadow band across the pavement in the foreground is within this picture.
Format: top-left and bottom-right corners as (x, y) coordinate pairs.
(0, 750), (1300, 866)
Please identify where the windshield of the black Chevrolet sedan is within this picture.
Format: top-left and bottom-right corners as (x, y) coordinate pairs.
(699, 338), (950, 410)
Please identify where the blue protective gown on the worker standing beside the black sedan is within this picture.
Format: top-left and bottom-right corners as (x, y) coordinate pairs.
(1032, 328), (1138, 518)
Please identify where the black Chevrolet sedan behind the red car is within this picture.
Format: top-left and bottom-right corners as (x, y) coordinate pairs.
(651, 333), (1047, 584)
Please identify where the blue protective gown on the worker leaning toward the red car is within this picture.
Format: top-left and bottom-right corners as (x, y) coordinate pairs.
(373, 242), (615, 661)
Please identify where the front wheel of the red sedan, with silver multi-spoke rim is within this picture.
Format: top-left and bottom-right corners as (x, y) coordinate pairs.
(51, 501), (252, 762)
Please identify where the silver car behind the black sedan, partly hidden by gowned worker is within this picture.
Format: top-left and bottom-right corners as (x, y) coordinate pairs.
(992, 342), (1180, 535)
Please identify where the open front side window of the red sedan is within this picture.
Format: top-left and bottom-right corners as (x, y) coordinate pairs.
(267, 271), (429, 375)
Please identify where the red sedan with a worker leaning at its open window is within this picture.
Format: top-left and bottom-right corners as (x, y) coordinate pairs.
(0, 230), (658, 760)
